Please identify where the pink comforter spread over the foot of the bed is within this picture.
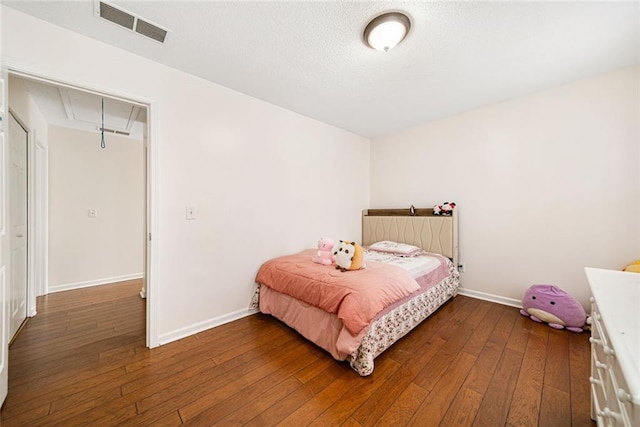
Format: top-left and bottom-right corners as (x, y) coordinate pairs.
(256, 249), (420, 335)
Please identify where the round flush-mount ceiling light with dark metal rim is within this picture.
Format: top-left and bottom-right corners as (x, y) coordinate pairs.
(364, 12), (411, 52)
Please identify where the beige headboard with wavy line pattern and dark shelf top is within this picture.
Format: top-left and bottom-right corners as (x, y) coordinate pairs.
(362, 208), (458, 268)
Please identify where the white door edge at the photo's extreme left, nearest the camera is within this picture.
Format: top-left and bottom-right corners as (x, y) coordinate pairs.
(0, 70), (9, 406)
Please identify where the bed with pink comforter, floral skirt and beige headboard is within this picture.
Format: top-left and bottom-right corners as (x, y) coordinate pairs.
(252, 209), (459, 376)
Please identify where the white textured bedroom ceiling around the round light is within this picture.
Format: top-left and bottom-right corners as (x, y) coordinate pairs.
(3, 0), (640, 138)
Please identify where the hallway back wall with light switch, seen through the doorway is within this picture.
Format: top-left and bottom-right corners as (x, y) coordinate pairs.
(49, 126), (146, 292)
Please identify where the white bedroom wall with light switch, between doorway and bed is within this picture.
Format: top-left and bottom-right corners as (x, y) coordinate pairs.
(1, 6), (370, 343)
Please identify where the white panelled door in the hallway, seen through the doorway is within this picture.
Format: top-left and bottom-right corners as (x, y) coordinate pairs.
(9, 113), (27, 340)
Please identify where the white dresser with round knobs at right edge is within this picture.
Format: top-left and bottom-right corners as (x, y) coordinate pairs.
(585, 268), (640, 427)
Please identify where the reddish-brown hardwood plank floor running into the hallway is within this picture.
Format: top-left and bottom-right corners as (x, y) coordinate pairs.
(0, 281), (595, 427)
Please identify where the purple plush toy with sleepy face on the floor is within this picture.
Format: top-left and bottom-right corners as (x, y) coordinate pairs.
(520, 285), (587, 332)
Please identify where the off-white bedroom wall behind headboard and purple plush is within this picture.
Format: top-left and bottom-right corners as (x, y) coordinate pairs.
(371, 67), (640, 308)
